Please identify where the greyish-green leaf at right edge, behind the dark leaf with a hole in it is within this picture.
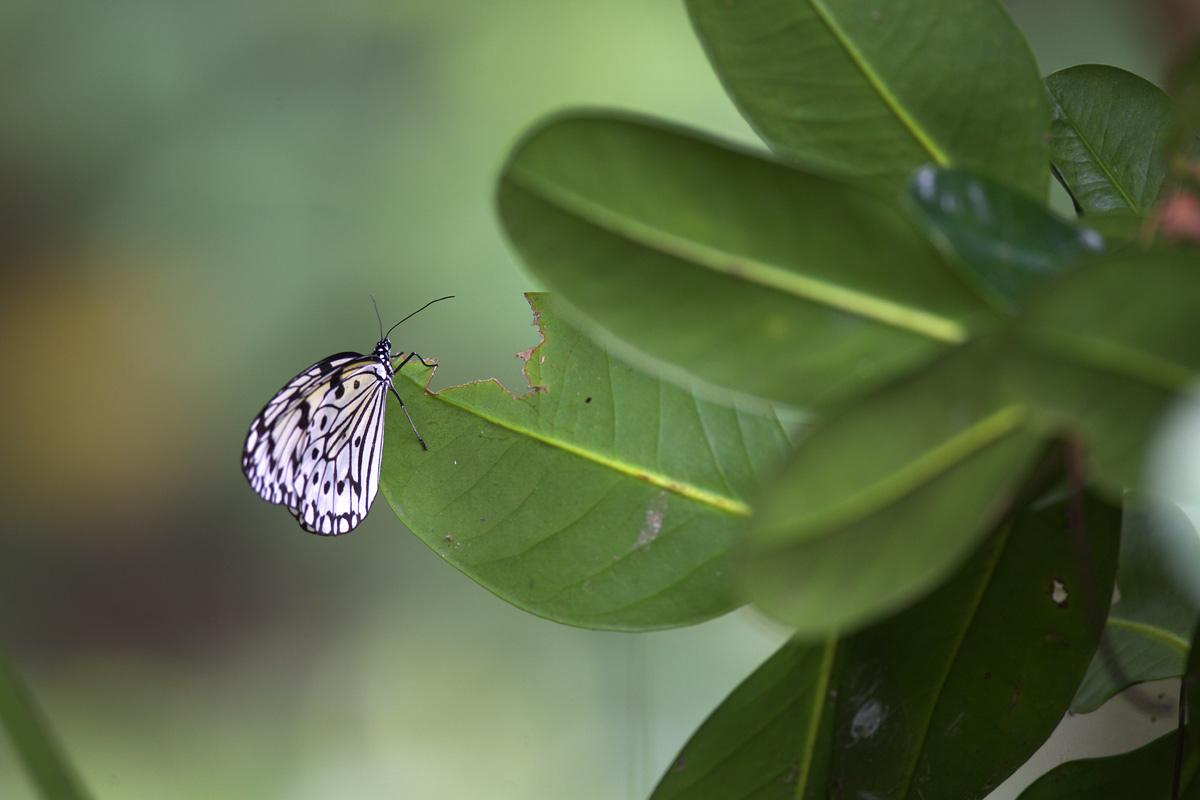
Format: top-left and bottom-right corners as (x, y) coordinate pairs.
(1070, 494), (1200, 712)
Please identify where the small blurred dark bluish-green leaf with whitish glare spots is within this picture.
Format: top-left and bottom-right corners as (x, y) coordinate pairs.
(906, 167), (1104, 311)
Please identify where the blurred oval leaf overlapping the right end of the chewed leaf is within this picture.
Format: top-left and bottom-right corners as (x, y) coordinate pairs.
(740, 338), (1042, 632)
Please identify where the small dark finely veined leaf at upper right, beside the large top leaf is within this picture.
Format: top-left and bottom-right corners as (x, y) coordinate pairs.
(1045, 64), (1174, 215)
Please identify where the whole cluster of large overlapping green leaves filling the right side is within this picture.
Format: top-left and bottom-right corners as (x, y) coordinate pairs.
(424, 0), (1200, 800)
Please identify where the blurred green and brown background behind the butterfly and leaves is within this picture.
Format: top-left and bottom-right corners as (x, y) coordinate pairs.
(0, 0), (1169, 800)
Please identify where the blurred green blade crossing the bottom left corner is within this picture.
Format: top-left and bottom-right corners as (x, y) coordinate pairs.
(0, 650), (89, 800)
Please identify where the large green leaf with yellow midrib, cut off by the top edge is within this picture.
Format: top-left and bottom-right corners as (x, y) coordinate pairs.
(688, 0), (1049, 198)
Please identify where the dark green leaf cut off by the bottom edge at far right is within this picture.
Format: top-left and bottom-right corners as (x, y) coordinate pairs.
(1018, 732), (1185, 800)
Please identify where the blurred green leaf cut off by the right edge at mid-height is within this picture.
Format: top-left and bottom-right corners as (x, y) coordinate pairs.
(1006, 252), (1200, 498)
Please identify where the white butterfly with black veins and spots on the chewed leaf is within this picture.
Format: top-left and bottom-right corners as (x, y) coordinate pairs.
(241, 295), (454, 536)
